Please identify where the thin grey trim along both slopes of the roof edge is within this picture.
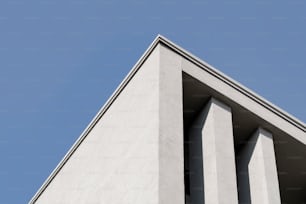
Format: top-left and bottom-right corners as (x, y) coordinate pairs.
(29, 34), (306, 204)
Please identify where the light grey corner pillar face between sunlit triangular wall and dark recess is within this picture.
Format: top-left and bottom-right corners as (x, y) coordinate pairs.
(158, 45), (185, 204)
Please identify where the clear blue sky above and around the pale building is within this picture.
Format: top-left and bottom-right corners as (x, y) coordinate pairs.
(0, 0), (306, 204)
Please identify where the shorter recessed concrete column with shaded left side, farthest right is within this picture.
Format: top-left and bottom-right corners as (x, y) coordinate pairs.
(237, 128), (281, 204)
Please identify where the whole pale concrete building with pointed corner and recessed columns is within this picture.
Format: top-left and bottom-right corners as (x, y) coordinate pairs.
(30, 36), (306, 204)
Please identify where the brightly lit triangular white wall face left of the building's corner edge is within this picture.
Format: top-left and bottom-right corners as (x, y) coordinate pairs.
(36, 45), (163, 204)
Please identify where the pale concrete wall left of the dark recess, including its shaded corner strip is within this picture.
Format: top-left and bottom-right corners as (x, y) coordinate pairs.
(36, 45), (184, 204)
